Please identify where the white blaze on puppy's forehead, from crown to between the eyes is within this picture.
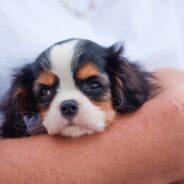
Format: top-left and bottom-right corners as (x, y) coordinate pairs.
(50, 40), (78, 88)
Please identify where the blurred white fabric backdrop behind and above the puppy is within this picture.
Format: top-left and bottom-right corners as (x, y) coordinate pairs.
(0, 0), (184, 97)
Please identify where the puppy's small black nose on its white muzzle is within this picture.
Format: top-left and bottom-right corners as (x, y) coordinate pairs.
(60, 100), (78, 119)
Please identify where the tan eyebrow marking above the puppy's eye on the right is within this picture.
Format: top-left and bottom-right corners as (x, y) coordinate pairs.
(76, 63), (100, 79)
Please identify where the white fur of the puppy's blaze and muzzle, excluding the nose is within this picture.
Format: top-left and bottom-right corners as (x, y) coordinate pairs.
(43, 40), (105, 137)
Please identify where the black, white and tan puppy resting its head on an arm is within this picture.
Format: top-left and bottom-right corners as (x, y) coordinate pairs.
(1, 39), (154, 137)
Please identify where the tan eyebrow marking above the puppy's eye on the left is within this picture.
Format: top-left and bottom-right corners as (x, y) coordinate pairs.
(36, 71), (57, 86)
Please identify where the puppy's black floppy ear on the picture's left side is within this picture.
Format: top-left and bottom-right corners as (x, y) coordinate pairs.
(0, 65), (35, 137)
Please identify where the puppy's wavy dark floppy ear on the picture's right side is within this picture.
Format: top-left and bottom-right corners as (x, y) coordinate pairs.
(107, 44), (153, 112)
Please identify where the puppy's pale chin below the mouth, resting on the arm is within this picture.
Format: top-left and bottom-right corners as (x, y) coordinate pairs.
(58, 125), (96, 137)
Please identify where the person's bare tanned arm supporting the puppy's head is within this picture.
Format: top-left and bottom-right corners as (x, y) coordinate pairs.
(0, 68), (184, 184)
